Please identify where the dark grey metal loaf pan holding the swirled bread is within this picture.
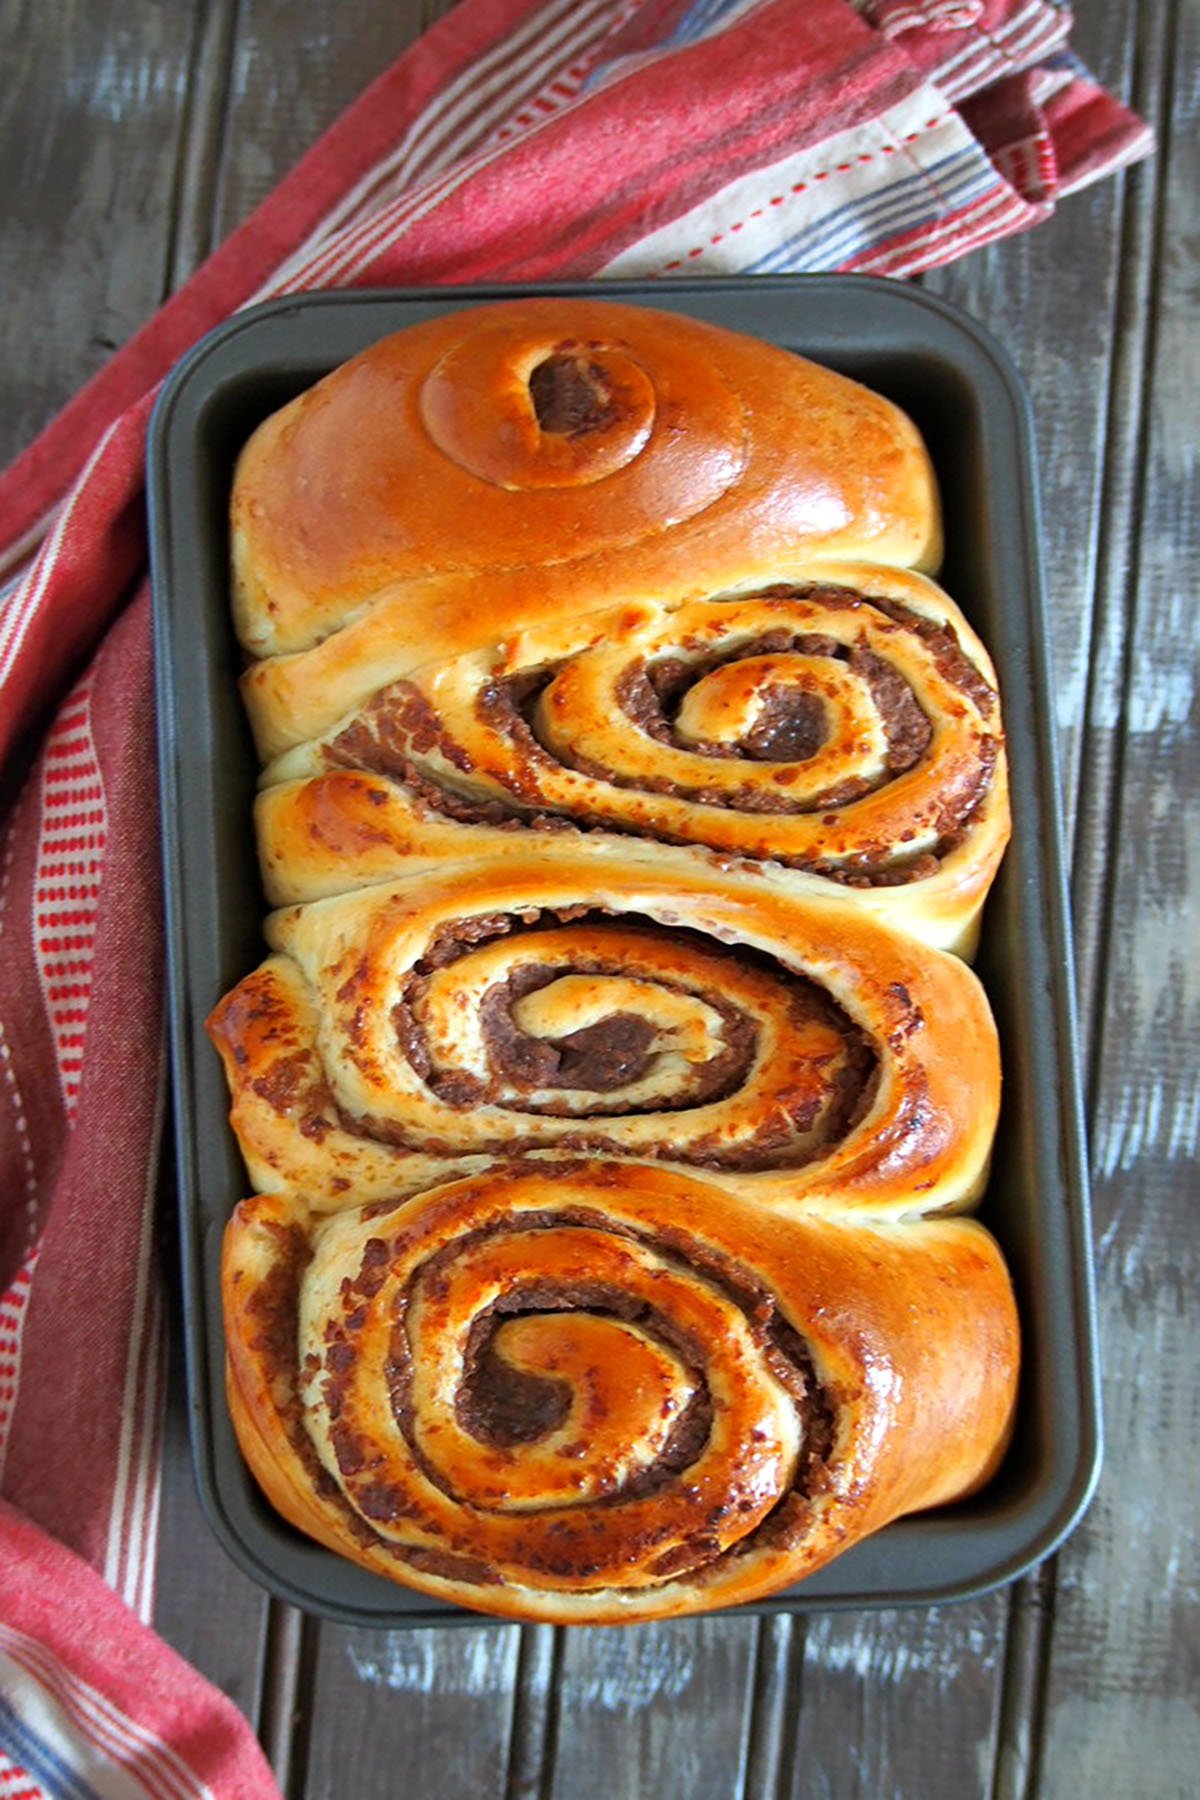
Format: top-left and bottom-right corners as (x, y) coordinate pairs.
(149, 275), (1099, 1627)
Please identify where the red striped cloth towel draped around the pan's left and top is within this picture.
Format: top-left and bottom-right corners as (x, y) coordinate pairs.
(0, 0), (1150, 1800)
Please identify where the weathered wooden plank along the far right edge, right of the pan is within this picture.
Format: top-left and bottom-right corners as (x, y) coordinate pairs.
(1042, 4), (1200, 1800)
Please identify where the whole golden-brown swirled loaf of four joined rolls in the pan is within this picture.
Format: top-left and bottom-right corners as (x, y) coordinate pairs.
(210, 299), (1018, 1622)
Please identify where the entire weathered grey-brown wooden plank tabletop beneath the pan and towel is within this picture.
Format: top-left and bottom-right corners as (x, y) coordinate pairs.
(0, 0), (1200, 1800)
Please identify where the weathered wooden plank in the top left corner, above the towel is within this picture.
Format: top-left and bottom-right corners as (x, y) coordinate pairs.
(0, 0), (194, 464)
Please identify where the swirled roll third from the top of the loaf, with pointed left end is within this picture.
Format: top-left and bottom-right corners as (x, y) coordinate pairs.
(210, 833), (1000, 1217)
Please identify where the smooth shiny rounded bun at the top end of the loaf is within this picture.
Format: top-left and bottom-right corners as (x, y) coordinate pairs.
(232, 297), (941, 661)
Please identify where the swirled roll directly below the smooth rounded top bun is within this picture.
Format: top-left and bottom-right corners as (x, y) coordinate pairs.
(259, 563), (1009, 954)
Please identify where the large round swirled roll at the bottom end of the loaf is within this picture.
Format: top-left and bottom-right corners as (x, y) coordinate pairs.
(225, 1163), (1016, 1624)
